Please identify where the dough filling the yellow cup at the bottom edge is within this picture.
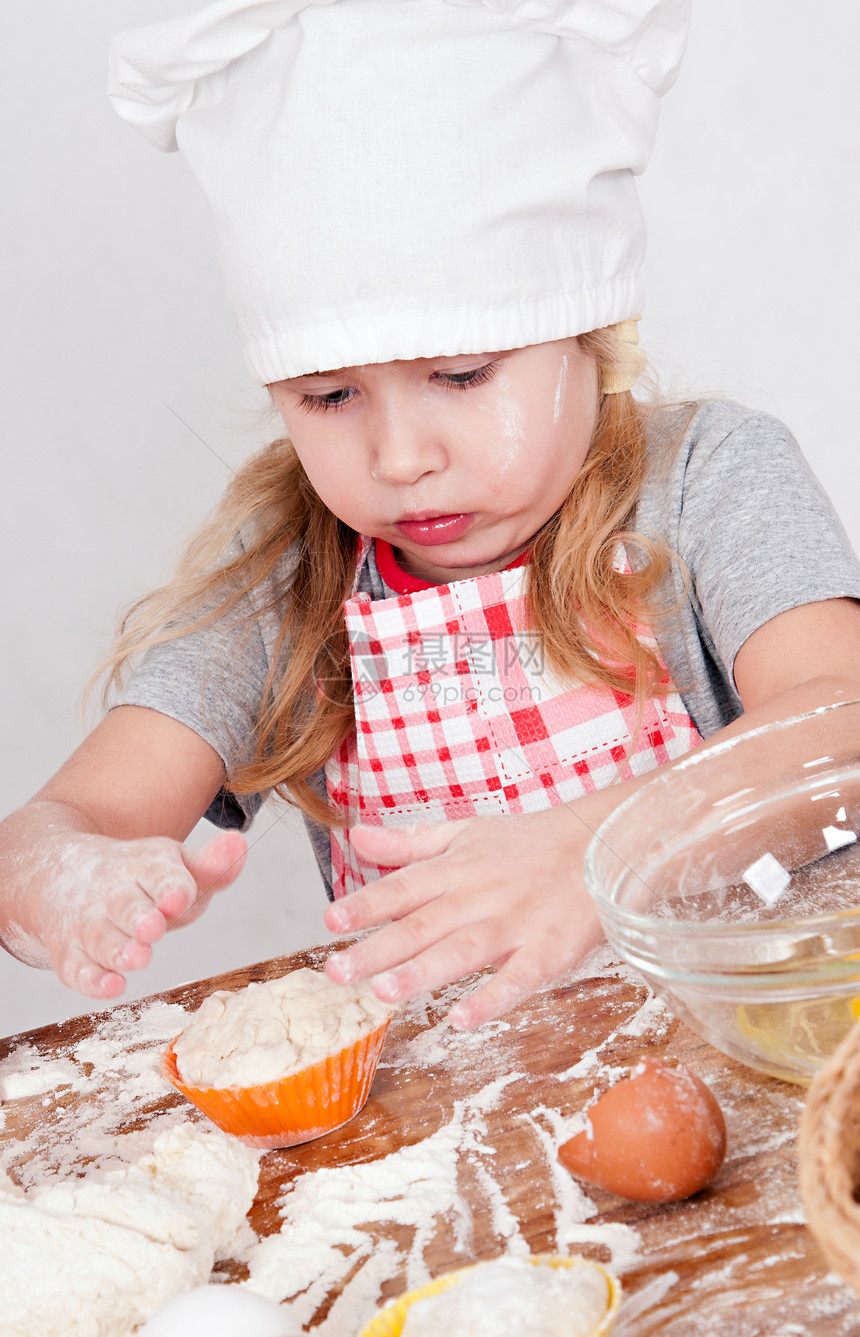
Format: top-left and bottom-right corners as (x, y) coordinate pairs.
(403, 1258), (610, 1337)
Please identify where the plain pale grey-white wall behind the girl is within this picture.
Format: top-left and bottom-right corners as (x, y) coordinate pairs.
(0, 0), (860, 1034)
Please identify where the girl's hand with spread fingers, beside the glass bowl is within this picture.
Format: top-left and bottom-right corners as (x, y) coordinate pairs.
(325, 800), (604, 1028)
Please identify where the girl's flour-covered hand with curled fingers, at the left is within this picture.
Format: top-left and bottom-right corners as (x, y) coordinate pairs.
(28, 832), (247, 999)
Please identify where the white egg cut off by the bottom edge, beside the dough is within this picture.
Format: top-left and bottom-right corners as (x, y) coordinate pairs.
(138, 1282), (301, 1337)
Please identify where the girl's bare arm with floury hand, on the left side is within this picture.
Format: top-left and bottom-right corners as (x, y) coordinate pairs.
(0, 706), (246, 999)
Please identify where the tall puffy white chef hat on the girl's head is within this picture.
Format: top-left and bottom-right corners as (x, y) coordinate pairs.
(110, 0), (689, 384)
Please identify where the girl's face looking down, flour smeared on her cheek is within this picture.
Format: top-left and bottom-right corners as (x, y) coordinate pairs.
(270, 340), (598, 583)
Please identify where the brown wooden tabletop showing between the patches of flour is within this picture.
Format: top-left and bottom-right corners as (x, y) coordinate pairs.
(0, 947), (860, 1337)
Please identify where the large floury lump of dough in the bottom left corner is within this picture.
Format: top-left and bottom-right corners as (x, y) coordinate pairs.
(0, 1124), (258, 1337)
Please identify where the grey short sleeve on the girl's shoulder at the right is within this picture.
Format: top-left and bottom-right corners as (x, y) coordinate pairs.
(635, 401), (860, 735)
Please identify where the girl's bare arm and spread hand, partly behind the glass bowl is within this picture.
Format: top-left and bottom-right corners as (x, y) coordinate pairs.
(325, 599), (860, 1027)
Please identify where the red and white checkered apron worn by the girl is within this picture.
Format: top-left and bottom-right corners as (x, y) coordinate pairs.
(325, 543), (701, 897)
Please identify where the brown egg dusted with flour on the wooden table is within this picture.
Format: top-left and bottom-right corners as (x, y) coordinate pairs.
(559, 1059), (726, 1202)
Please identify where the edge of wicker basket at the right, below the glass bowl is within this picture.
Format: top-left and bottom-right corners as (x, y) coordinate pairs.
(798, 1023), (860, 1296)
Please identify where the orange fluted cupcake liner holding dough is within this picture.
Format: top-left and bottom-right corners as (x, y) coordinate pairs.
(162, 1019), (391, 1151)
